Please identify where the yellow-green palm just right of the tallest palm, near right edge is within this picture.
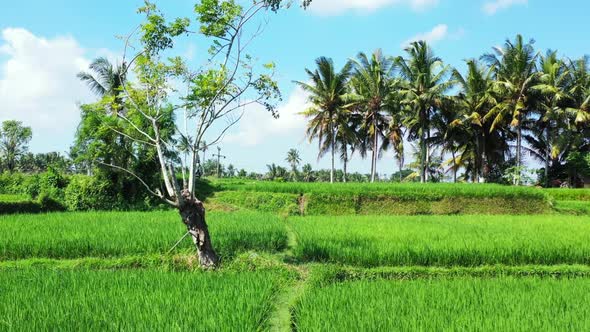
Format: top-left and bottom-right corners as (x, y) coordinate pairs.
(532, 50), (571, 187)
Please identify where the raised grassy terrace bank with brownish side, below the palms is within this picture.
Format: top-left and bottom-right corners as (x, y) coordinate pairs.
(214, 181), (551, 215)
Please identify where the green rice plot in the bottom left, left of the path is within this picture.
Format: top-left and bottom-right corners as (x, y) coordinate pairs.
(0, 269), (282, 331)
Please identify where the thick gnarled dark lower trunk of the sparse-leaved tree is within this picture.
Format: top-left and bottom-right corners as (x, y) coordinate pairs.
(178, 191), (219, 268)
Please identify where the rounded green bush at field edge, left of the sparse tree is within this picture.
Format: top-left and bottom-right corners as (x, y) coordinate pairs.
(64, 175), (117, 211)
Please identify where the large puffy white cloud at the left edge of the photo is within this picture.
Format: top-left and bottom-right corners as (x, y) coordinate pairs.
(0, 28), (92, 152)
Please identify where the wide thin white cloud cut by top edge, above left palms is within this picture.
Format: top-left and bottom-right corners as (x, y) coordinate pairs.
(309, 0), (439, 15)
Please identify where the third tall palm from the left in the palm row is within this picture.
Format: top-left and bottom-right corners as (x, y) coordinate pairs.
(396, 41), (454, 182)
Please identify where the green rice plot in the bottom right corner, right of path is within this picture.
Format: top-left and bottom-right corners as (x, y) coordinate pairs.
(294, 278), (590, 331)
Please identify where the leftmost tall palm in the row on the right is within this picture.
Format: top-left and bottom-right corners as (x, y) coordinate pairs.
(295, 57), (350, 183)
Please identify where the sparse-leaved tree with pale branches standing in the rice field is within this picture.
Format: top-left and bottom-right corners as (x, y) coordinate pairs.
(91, 0), (307, 267)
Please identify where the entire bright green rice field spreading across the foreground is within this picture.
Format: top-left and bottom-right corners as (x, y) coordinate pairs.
(0, 183), (590, 331)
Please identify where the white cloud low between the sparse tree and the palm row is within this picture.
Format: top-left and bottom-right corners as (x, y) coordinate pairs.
(224, 87), (309, 146)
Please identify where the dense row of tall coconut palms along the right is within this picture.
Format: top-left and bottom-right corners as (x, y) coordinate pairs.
(300, 35), (590, 187)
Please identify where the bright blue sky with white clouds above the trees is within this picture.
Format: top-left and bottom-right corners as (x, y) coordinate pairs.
(0, 0), (590, 173)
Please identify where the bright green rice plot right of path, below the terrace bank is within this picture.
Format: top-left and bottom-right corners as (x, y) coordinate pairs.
(291, 215), (590, 267)
